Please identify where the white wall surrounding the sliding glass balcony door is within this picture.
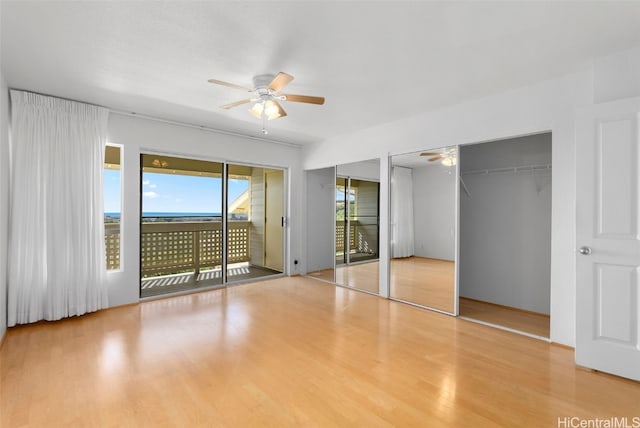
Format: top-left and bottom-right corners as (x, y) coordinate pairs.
(108, 114), (303, 306)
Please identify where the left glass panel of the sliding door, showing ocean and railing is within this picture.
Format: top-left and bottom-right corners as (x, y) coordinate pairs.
(140, 154), (223, 297)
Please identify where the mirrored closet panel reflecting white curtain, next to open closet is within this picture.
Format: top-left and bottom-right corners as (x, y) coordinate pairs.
(389, 147), (458, 314)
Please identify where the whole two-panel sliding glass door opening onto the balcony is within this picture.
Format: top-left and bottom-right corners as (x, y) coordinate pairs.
(140, 154), (284, 297)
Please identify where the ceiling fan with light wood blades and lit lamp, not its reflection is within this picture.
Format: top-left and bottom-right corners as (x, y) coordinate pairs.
(209, 71), (324, 134)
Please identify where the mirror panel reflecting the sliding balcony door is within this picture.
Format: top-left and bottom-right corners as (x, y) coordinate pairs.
(334, 159), (380, 294)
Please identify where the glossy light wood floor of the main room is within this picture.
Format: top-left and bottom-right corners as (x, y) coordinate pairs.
(0, 277), (640, 427)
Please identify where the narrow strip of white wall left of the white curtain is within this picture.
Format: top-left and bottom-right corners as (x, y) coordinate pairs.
(0, 69), (9, 342)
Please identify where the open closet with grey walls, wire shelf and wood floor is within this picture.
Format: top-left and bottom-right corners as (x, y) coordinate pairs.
(459, 133), (552, 338)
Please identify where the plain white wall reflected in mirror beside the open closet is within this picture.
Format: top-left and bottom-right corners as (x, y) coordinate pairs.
(412, 164), (457, 260)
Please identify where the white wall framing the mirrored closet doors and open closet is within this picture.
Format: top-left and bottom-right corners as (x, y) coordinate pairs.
(304, 70), (593, 346)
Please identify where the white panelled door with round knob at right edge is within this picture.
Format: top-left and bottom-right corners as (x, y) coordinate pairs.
(576, 98), (640, 380)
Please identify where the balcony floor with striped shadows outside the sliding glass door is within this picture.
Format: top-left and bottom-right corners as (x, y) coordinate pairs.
(140, 263), (281, 297)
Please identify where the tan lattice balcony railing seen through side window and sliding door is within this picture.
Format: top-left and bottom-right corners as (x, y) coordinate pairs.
(105, 221), (251, 277)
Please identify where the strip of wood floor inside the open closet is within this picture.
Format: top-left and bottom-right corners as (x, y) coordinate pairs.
(459, 297), (550, 338)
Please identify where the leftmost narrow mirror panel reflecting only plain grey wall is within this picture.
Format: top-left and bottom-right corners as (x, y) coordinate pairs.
(306, 167), (336, 282)
